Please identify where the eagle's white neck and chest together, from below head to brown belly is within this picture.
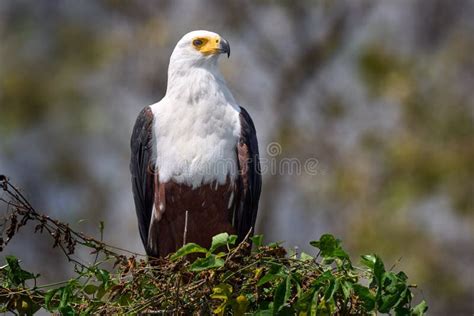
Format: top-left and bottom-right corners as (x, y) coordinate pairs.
(152, 53), (240, 187)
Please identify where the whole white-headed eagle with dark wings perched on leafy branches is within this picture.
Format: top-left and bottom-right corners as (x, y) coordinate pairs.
(130, 30), (262, 257)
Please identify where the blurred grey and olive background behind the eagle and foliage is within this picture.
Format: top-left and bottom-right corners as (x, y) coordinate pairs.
(0, 0), (474, 315)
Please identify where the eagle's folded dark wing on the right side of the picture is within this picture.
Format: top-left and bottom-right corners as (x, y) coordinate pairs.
(233, 107), (262, 240)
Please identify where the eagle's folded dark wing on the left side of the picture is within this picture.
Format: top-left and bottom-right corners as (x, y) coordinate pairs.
(130, 107), (155, 253)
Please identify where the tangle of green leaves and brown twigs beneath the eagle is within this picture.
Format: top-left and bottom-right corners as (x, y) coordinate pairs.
(0, 177), (427, 315)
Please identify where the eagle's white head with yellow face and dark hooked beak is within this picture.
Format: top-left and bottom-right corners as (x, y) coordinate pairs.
(170, 30), (230, 65)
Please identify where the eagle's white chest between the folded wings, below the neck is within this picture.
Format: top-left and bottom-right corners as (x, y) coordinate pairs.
(151, 97), (240, 187)
